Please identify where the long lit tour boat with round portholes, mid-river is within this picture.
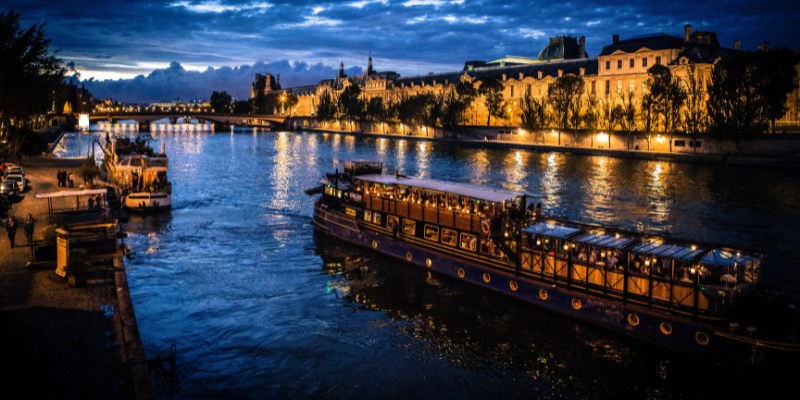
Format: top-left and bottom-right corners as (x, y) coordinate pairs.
(307, 161), (800, 366)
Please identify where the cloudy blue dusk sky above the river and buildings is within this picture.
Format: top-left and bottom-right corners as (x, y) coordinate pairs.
(0, 0), (800, 101)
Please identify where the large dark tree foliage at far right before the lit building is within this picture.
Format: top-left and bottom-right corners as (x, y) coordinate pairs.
(707, 49), (797, 135)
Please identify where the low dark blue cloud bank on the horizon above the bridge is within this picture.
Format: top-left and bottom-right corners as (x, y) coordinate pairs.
(82, 60), (362, 103)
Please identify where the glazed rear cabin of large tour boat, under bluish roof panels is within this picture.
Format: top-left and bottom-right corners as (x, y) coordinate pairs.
(520, 221), (761, 318)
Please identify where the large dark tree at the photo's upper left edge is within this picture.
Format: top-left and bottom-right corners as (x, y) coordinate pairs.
(0, 10), (65, 134)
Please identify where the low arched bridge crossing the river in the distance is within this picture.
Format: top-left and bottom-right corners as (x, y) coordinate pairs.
(89, 113), (290, 129)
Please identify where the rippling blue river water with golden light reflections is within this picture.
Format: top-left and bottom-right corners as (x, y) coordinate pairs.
(90, 133), (800, 399)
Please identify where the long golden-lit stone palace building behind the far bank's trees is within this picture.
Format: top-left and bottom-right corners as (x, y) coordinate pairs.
(252, 25), (800, 131)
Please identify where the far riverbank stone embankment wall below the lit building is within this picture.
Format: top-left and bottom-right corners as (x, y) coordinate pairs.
(301, 127), (800, 168)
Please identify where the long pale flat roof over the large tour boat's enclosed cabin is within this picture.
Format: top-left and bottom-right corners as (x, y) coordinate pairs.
(356, 174), (530, 203)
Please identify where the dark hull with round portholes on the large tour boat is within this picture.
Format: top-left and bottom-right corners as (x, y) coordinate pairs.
(313, 203), (800, 368)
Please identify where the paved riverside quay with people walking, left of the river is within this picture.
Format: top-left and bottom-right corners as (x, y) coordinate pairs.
(0, 157), (134, 399)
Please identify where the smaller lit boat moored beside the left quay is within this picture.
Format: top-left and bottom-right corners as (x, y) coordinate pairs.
(106, 138), (172, 212)
